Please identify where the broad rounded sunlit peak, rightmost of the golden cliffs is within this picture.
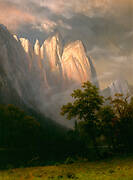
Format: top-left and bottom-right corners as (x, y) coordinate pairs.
(62, 40), (91, 83)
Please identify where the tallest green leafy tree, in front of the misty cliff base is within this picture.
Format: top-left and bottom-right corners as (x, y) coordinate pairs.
(61, 81), (104, 156)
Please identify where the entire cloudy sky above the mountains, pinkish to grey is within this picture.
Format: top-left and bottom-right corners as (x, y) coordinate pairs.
(0, 0), (133, 88)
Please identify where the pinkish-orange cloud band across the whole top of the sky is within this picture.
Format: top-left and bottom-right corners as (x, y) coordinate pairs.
(0, 0), (133, 32)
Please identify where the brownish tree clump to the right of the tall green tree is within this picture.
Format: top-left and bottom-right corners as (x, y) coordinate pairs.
(98, 94), (133, 152)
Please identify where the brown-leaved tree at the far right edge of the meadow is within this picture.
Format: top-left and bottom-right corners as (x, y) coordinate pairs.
(109, 94), (133, 151)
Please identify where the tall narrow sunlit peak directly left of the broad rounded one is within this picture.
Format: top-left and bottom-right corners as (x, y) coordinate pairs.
(41, 33), (63, 89)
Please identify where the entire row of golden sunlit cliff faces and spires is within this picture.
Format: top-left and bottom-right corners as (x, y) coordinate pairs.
(14, 33), (96, 90)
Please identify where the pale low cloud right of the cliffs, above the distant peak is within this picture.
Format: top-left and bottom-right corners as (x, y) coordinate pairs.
(88, 45), (133, 89)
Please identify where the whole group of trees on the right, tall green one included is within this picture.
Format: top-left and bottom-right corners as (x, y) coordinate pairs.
(61, 82), (133, 156)
